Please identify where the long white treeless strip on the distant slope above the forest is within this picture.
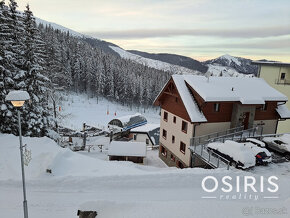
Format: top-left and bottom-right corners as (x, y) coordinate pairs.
(110, 46), (201, 74)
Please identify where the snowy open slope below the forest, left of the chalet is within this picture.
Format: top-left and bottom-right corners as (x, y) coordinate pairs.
(59, 93), (160, 130)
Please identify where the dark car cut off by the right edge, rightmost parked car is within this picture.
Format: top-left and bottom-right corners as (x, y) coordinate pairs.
(263, 134), (290, 160)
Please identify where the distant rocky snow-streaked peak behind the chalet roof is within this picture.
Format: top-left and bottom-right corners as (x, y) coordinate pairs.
(203, 54), (258, 75)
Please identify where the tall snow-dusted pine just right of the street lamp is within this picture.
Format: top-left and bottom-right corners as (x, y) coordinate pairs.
(23, 5), (50, 136)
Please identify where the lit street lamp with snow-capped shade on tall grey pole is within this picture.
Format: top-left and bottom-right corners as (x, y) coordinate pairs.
(6, 91), (30, 218)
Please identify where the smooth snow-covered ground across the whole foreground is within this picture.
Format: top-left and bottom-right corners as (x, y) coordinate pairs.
(0, 134), (290, 218)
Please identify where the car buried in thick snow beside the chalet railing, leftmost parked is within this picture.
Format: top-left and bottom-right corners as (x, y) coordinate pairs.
(207, 140), (256, 169)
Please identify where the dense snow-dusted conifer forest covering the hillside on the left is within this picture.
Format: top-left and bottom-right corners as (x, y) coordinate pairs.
(0, 0), (170, 136)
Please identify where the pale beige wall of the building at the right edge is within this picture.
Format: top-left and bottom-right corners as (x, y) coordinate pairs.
(260, 66), (290, 133)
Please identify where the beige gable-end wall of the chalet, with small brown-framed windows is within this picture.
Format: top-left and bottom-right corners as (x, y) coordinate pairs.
(160, 109), (193, 166)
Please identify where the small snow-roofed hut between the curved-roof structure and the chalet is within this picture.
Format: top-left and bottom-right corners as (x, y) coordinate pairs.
(130, 123), (160, 146)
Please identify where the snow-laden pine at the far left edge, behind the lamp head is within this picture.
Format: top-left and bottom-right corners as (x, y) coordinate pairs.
(0, 0), (23, 134)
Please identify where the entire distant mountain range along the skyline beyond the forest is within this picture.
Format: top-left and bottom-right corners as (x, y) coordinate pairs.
(36, 18), (258, 76)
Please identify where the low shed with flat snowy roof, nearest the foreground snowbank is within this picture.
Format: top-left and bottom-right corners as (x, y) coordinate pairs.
(108, 141), (146, 164)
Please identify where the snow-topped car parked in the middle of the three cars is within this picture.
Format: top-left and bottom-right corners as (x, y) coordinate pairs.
(242, 142), (272, 165)
